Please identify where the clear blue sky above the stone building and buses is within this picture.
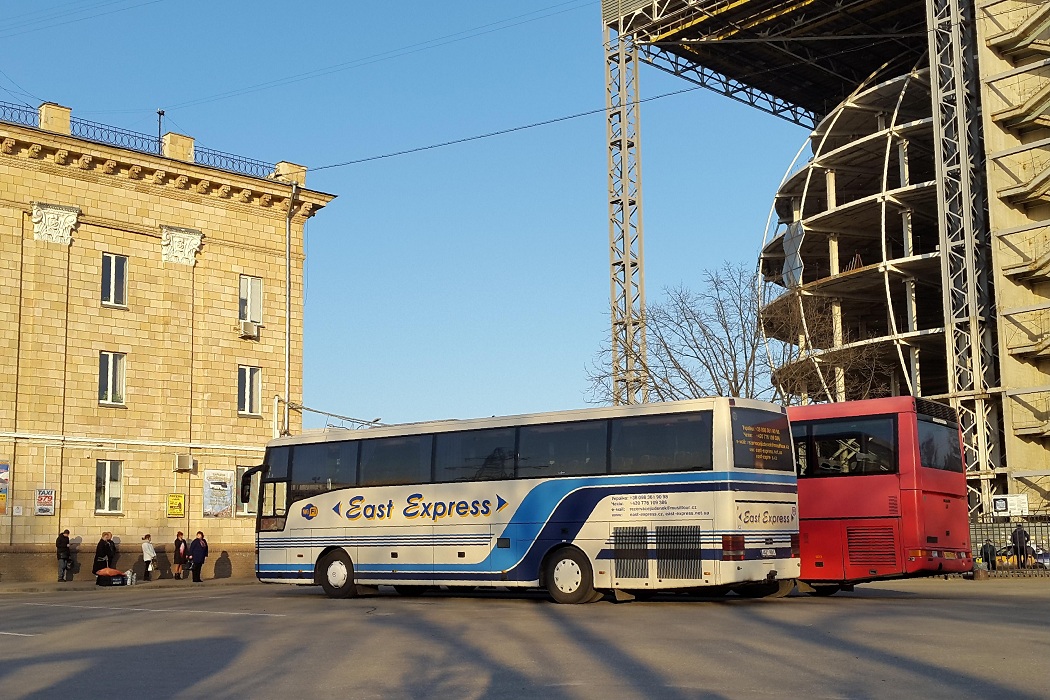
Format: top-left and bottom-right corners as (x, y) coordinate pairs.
(0, 0), (806, 427)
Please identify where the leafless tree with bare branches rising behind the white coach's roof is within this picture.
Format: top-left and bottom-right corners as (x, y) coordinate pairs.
(588, 262), (889, 404)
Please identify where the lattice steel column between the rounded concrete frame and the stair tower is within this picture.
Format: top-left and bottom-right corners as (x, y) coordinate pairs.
(926, 0), (1003, 510)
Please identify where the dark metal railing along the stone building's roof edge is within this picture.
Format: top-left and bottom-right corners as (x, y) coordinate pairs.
(0, 102), (276, 178)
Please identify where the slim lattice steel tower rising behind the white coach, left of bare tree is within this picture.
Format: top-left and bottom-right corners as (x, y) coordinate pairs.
(604, 20), (649, 405)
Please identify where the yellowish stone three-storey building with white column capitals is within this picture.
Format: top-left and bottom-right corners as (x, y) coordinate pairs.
(0, 99), (333, 581)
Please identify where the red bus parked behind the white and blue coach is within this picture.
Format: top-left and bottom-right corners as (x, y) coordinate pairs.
(788, 397), (973, 595)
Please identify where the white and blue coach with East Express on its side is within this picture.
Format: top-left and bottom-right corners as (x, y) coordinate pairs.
(240, 398), (799, 603)
